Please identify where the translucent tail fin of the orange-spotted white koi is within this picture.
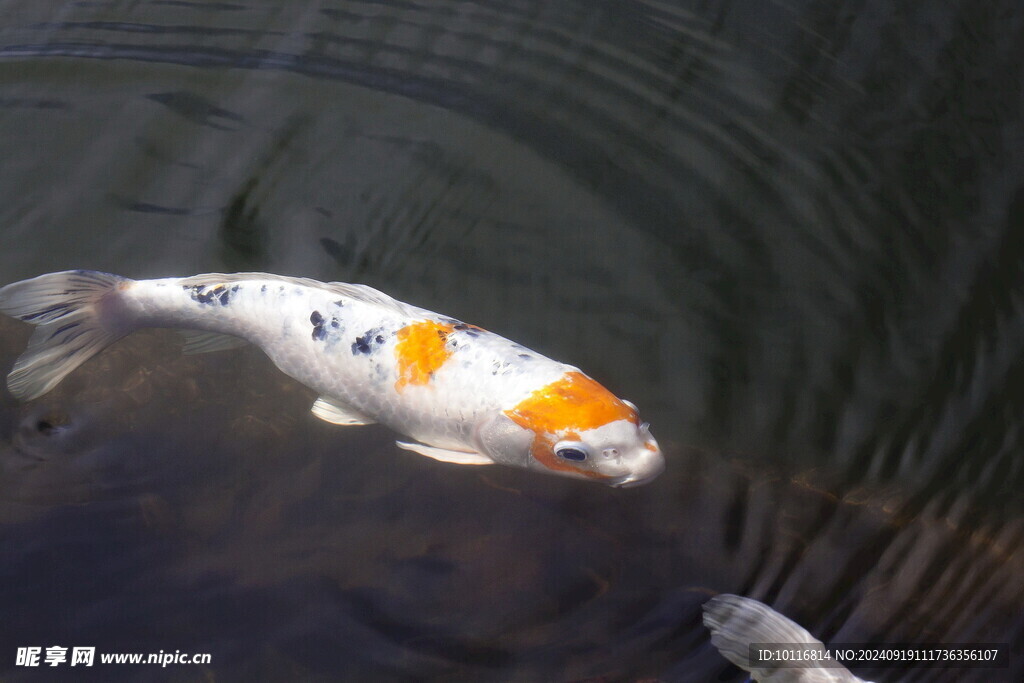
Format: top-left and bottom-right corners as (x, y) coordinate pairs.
(0, 270), (131, 400)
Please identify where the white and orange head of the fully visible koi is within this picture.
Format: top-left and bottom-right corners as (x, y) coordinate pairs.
(478, 372), (665, 486)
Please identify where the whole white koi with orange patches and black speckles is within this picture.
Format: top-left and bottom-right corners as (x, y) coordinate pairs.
(0, 270), (665, 486)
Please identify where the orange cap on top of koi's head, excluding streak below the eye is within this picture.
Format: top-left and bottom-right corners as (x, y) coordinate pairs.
(505, 372), (638, 434)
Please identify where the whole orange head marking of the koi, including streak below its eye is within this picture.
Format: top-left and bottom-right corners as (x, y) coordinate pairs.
(505, 372), (638, 479)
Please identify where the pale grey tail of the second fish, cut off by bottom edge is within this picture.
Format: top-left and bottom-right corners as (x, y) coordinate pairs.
(703, 593), (863, 683)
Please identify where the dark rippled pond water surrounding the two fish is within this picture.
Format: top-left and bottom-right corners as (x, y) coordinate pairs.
(0, 0), (1024, 681)
